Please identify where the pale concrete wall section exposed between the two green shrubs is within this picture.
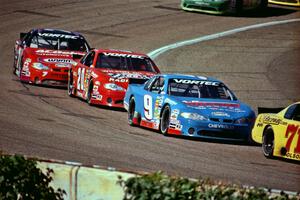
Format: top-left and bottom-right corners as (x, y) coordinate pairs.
(38, 161), (135, 200)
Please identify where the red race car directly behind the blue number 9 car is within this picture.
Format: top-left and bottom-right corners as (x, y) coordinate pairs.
(68, 49), (160, 108)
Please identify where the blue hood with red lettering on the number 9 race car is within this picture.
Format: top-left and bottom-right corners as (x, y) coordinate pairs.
(173, 97), (255, 119)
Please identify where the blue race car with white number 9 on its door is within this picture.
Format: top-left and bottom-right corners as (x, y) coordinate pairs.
(124, 74), (255, 141)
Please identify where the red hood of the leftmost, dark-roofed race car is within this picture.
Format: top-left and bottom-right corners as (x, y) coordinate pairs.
(28, 48), (84, 68)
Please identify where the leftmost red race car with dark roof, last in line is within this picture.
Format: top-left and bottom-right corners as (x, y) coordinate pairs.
(14, 29), (90, 86)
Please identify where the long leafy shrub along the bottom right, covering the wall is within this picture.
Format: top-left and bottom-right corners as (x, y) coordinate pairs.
(118, 172), (297, 200)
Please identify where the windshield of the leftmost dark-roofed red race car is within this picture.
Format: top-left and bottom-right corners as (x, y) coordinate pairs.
(30, 33), (88, 52)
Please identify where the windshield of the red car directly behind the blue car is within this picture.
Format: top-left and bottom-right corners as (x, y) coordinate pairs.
(96, 53), (156, 72)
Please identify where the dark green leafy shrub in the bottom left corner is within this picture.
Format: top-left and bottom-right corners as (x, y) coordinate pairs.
(0, 153), (65, 200)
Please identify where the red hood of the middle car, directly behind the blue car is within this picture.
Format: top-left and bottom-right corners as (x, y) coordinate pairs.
(92, 69), (156, 88)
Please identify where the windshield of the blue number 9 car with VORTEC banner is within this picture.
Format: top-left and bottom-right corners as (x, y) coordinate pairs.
(168, 79), (236, 100)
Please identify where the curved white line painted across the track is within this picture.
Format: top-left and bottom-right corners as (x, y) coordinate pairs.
(148, 18), (300, 59)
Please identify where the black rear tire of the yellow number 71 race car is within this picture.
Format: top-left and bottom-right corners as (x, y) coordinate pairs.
(262, 126), (274, 158)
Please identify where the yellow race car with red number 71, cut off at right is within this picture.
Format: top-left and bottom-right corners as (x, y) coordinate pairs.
(252, 102), (300, 160)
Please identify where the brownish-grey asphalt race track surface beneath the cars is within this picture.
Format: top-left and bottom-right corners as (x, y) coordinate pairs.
(0, 0), (300, 192)
